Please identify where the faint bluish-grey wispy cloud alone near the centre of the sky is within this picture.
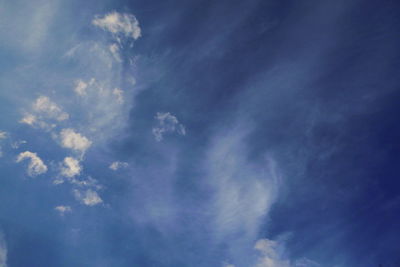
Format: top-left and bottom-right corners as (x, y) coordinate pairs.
(152, 112), (186, 142)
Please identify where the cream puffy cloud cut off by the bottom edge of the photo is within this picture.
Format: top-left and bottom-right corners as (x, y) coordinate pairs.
(254, 239), (290, 267)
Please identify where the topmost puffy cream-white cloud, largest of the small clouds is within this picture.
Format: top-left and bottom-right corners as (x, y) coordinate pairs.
(92, 11), (141, 40)
